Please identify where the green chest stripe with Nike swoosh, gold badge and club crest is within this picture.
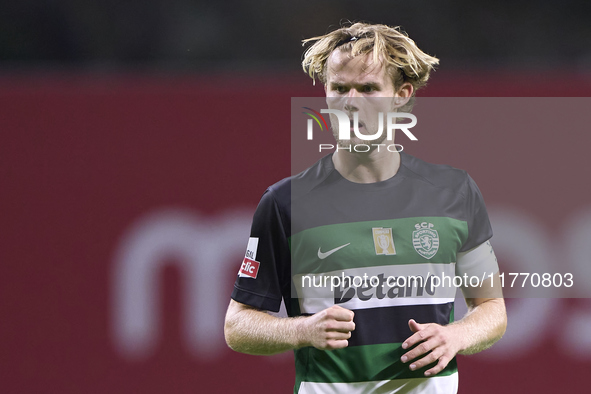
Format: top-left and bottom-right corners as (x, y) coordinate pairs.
(289, 217), (468, 275)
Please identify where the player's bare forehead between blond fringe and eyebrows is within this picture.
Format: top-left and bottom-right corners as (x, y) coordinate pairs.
(326, 49), (390, 84)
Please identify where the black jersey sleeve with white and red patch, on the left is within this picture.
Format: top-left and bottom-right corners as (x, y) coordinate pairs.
(232, 189), (290, 312)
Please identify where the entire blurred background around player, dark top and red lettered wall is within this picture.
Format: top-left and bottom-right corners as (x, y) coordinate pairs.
(0, 0), (591, 394)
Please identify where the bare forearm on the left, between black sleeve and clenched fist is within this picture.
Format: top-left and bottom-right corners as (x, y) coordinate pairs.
(224, 309), (304, 355)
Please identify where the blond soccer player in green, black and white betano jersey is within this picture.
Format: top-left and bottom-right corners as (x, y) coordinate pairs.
(224, 23), (506, 394)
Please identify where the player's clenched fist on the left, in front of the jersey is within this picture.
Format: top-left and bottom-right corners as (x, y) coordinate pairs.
(303, 305), (355, 350)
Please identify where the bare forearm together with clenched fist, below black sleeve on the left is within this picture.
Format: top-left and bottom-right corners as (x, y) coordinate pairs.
(224, 300), (355, 355)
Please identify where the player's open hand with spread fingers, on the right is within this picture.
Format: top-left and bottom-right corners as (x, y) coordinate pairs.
(401, 319), (462, 376)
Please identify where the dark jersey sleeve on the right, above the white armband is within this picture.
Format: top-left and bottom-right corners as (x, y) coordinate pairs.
(459, 175), (492, 252)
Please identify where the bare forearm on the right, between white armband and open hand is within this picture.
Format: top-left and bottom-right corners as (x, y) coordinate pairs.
(452, 298), (507, 355)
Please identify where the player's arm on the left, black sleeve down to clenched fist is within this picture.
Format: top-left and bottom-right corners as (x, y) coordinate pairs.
(224, 186), (355, 355)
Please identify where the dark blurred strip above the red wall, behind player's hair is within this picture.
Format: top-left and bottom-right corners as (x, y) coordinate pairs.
(0, 0), (591, 75)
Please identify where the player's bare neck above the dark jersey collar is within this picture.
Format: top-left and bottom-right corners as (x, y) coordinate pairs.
(332, 150), (400, 183)
